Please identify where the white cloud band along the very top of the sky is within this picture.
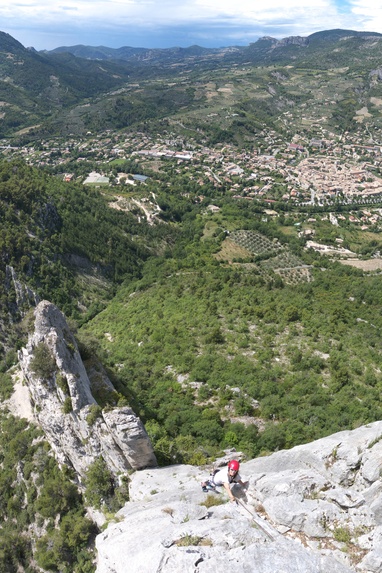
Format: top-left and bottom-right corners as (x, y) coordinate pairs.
(0, 0), (346, 26)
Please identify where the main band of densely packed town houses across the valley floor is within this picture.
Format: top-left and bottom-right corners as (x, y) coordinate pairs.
(0, 124), (382, 208)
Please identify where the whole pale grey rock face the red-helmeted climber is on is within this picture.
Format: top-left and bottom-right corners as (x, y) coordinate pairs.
(96, 422), (382, 573)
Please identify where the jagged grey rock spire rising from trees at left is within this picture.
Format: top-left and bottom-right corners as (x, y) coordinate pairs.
(19, 301), (157, 477)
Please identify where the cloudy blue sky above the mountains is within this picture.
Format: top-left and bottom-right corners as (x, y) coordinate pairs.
(0, 0), (382, 50)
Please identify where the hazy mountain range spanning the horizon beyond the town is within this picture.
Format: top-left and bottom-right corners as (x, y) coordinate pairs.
(0, 30), (382, 139)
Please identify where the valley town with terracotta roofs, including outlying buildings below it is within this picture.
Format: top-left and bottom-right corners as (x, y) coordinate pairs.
(0, 123), (382, 248)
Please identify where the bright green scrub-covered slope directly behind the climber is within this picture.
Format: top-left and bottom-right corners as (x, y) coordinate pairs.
(79, 203), (382, 462)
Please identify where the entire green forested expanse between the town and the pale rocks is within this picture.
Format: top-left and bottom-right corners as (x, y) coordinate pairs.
(1, 152), (382, 470)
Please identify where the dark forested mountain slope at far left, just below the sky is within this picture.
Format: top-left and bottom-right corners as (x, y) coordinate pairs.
(0, 32), (136, 137)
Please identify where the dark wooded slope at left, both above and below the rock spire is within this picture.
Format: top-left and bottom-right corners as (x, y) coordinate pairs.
(0, 161), (178, 573)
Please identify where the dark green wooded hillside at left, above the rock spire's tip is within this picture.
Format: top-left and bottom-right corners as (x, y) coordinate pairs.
(0, 161), (172, 358)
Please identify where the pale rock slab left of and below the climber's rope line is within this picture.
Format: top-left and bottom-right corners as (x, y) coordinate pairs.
(96, 464), (354, 573)
